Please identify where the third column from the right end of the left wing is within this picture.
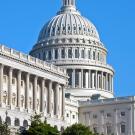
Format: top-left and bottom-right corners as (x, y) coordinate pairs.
(48, 80), (52, 114)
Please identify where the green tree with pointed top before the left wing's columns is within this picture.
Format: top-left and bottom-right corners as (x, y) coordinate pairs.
(21, 115), (59, 135)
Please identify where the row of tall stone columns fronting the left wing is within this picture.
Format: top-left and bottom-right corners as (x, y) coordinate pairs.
(0, 64), (65, 117)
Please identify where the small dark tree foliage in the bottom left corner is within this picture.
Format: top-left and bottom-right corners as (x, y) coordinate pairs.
(0, 123), (10, 135)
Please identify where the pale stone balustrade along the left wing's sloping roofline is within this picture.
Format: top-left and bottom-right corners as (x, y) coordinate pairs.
(0, 45), (66, 75)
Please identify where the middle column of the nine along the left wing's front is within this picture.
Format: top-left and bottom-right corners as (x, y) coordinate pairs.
(33, 76), (38, 111)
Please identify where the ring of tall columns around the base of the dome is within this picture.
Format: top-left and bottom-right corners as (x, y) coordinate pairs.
(67, 69), (113, 92)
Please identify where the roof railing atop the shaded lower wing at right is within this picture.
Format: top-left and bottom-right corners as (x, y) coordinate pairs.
(79, 96), (135, 106)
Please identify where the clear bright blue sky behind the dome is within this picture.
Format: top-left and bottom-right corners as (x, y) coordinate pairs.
(0, 0), (135, 96)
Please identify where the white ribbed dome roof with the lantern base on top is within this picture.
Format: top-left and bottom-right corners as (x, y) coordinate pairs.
(38, 0), (99, 42)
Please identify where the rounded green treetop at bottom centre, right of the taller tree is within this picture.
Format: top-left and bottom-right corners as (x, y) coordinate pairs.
(62, 124), (96, 135)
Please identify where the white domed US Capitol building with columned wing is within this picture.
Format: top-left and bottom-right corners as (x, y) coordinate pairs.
(0, 0), (135, 135)
